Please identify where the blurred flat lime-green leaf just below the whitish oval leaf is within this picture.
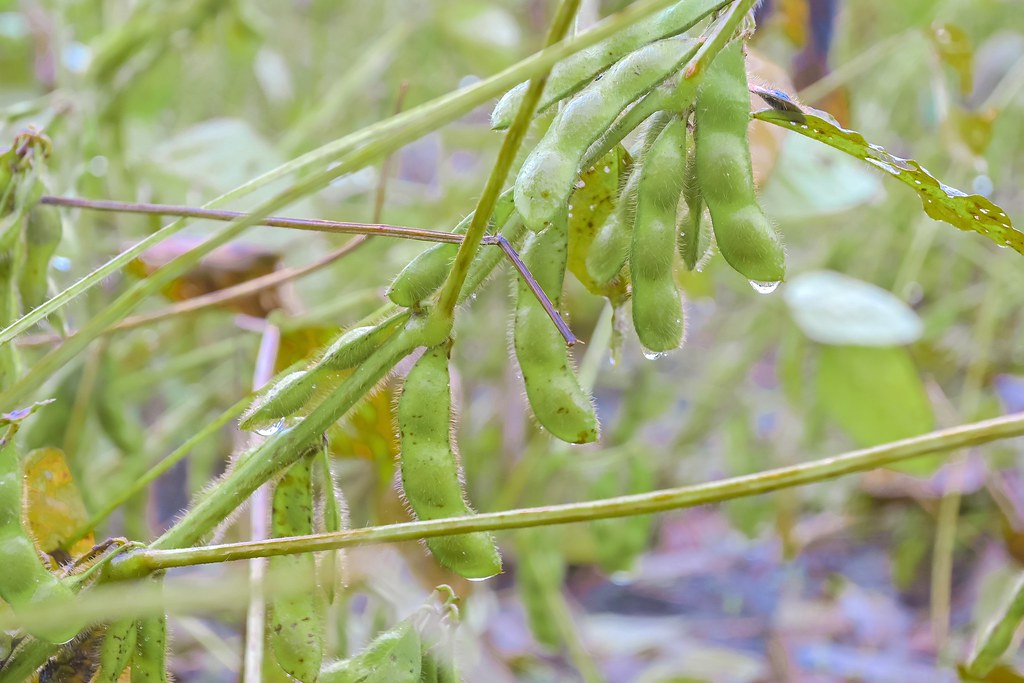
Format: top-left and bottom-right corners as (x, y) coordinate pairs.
(817, 346), (939, 475)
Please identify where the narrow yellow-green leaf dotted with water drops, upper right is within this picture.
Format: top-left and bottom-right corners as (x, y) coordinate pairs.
(754, 108), (1024, 254)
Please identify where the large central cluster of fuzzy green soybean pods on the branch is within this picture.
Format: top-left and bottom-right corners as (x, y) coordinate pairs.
(235, 0), (784, 680)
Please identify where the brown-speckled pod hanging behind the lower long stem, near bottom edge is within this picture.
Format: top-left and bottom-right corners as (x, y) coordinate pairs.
(267, 449), (324, 682)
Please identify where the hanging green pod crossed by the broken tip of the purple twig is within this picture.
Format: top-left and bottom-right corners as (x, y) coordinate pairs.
(512, 223), (599, 443)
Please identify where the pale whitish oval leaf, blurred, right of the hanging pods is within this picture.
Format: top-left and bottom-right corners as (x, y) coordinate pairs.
(782, 270), (924, 346)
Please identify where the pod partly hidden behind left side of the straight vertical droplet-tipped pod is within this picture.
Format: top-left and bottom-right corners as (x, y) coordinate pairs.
(587, 113), (671, 283)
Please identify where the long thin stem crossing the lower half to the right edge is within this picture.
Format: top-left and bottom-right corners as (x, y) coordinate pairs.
(110, 413), (1024, 578)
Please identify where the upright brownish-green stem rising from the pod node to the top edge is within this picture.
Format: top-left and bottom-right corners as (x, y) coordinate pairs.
(435, 0), (580, 327)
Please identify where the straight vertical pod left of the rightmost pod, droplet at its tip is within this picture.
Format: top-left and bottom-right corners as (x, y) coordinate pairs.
(630, 117), (686, 353)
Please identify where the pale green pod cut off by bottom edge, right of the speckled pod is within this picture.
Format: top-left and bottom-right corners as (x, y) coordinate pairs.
(319, 620), (422, 683)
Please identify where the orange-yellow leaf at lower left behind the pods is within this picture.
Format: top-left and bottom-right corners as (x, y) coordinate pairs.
(23, 447), (94, 557)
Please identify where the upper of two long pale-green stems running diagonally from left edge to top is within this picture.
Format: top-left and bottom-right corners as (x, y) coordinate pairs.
(0, 0), (688, 344)
